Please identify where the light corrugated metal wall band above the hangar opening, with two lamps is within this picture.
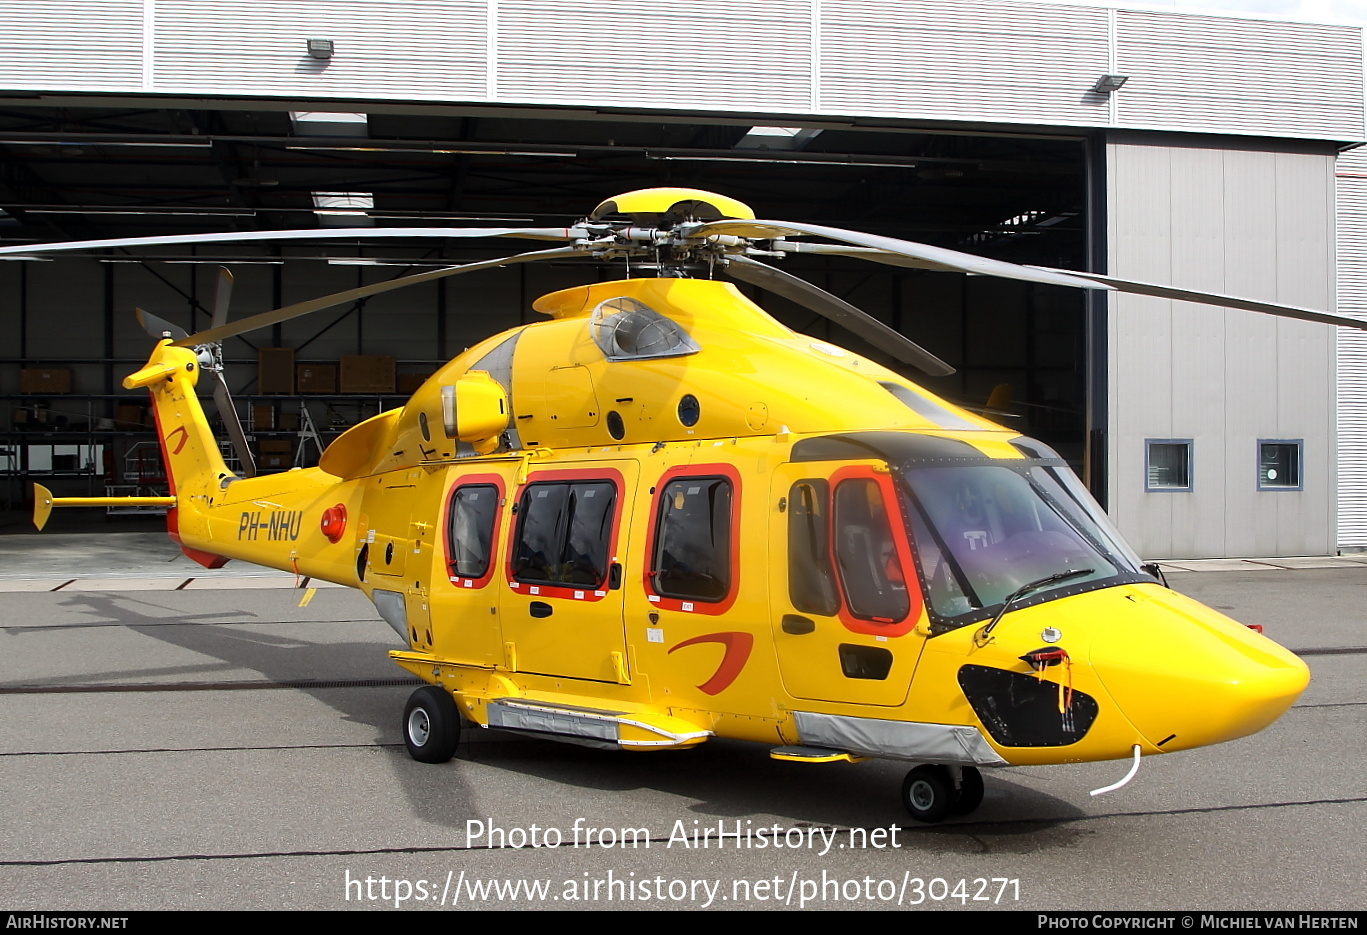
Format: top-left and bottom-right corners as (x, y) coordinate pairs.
(0, 0), (1364, 139)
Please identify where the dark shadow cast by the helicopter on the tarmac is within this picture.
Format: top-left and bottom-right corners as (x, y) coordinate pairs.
(21, 589), (1083, 853)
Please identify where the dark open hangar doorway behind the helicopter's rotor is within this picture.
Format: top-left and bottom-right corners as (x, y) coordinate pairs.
(0, 101), (1089, 508)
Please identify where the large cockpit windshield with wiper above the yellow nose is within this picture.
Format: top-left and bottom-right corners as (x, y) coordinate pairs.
(897, 437), (1148, 630)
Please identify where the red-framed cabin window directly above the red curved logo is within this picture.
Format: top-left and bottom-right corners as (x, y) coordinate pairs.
(651, 477), (731, 601)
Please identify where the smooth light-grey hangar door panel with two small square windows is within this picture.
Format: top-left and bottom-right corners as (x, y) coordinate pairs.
(1106, 135), (1337, 558)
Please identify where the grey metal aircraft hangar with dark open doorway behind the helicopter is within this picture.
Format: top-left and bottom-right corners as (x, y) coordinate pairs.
(0, 0), (1367, 558)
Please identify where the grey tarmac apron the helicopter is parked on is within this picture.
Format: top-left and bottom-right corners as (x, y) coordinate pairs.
(0, 533), (1367, 910)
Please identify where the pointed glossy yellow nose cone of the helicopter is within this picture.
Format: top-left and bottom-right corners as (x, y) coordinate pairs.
(1091, 588), (1310, 750)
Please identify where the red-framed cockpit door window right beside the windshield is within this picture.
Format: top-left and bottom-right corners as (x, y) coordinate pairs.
(833, 477), (912, 623)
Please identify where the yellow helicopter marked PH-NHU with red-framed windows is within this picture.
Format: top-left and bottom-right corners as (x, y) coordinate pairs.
(21, 189), (1345, 822)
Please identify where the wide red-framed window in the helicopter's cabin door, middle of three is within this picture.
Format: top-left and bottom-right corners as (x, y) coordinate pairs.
(513, 481), (617, 588)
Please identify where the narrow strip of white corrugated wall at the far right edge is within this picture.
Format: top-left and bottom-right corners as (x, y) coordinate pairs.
(1336, 148), (1367, 551)
